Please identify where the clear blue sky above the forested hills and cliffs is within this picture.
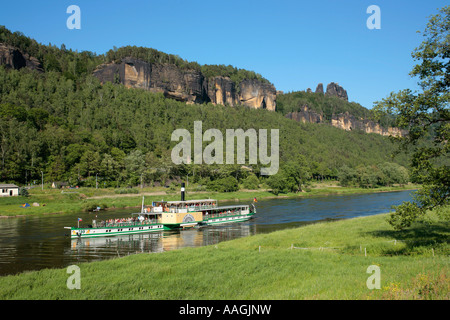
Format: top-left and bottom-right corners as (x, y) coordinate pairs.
(0, 0), (447, 108)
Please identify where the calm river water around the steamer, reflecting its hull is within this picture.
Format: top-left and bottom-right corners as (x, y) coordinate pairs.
(0, 191), (411, 276)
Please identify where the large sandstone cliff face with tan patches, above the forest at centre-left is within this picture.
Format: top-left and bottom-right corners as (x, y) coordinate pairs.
(94, 58), (277, 111)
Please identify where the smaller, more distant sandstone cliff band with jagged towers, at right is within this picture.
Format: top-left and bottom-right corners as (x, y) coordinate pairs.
(286, 106), (408, 137)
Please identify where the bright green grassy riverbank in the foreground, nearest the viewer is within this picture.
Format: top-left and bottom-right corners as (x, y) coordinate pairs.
(0, 208), (450, 300)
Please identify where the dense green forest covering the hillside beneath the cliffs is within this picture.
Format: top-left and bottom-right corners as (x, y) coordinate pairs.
(0, 27), (408, 192)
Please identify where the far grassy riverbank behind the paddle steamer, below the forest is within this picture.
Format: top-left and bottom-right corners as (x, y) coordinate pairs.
(0, 183), (418, 218)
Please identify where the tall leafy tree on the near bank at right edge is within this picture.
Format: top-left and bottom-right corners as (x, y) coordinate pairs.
(374, 6), (450, 230)
